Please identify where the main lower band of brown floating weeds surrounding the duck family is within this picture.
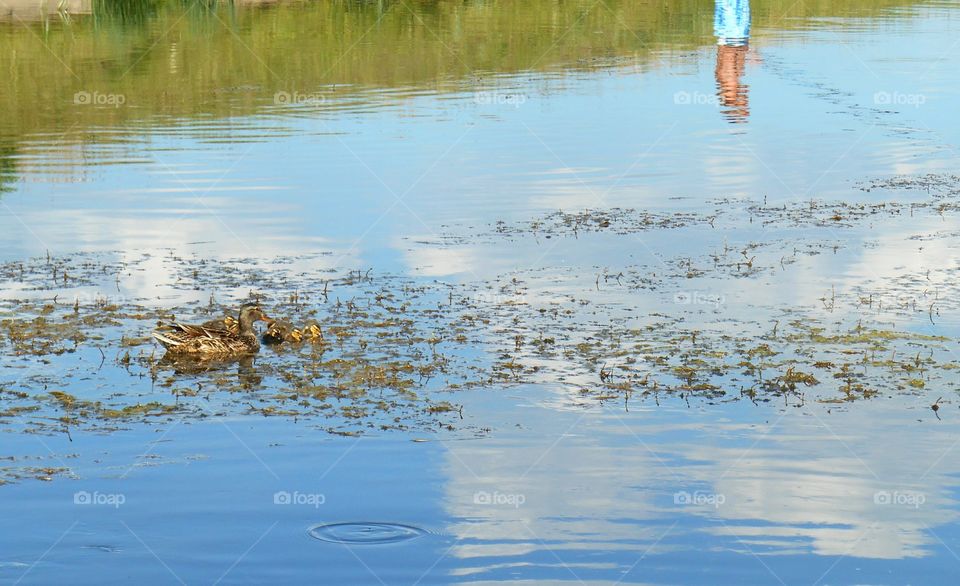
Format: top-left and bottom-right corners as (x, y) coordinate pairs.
(0, 250), (956, 466)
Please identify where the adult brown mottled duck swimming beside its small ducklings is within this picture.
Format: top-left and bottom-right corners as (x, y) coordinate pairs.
(153, 303), (270, 356)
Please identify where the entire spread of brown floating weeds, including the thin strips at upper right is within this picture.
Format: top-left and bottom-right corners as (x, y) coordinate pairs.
(0, 172), (958, 476)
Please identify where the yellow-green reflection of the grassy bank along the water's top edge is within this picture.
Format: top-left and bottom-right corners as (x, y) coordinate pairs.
(0, 0), (917, 149)
